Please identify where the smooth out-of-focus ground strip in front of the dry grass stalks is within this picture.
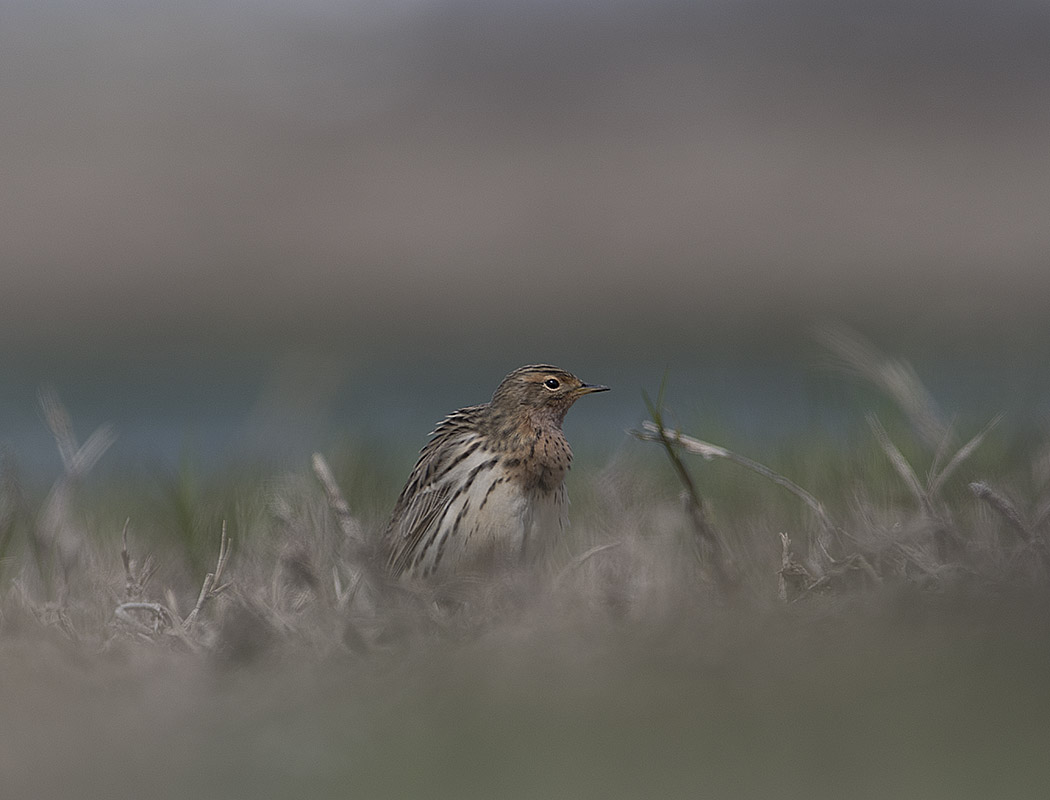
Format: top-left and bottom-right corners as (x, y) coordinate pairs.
(0, 595), (1050, 798)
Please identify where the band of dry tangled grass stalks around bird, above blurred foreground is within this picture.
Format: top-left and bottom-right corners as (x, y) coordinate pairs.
(0, 328), (1050, 657)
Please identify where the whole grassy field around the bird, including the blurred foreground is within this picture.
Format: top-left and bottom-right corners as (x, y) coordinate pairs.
(0, 329), (1050, 798)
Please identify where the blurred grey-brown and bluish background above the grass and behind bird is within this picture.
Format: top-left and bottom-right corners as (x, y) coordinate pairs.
(0, 0), (1050, 470)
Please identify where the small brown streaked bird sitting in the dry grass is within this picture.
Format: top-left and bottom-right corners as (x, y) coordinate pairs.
(383, 364), (609, 577)
